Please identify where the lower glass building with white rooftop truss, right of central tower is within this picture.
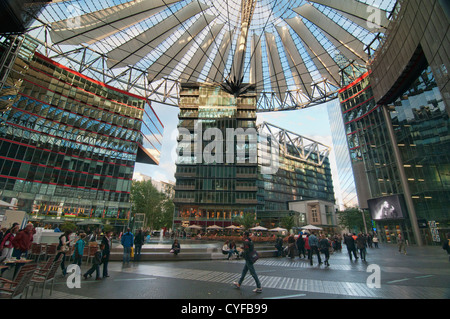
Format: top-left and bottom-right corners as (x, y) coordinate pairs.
(257, 123), (335, 228)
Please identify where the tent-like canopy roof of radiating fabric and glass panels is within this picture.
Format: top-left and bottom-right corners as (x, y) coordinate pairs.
(28, 0), (396, 112)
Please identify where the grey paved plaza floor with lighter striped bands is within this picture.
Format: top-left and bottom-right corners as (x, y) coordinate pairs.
(29, 245), (450, 300)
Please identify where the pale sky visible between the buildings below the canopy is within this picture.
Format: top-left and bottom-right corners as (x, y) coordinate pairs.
(135, 103), (335, 182)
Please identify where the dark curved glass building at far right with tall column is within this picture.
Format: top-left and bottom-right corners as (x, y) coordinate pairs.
(339, 1), (450, 245)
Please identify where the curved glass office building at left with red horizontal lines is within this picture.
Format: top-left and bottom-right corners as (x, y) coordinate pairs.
(0, 36), (163, 226)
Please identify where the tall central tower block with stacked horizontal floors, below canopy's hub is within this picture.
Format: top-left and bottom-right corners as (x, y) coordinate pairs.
(174, 84), (258, 228)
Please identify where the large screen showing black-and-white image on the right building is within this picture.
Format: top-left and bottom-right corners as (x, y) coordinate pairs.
(367, 195), (406, 220)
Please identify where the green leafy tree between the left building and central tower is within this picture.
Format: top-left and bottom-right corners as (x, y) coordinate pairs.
(130, 181), (174, 229)
